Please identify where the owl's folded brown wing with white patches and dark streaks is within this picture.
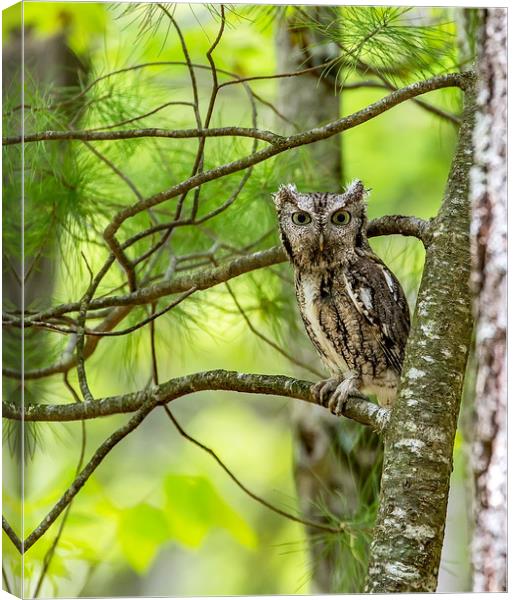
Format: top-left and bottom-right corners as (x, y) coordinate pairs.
(343, 253), (410, 373)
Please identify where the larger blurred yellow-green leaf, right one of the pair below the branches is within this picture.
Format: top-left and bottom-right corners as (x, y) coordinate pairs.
(164, 474), (257, 548)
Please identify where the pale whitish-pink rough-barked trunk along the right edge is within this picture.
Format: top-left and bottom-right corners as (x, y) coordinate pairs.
(471, 9), (507, 592)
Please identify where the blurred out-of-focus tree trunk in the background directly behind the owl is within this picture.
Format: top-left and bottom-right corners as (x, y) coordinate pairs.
(276, 7), (381, 593)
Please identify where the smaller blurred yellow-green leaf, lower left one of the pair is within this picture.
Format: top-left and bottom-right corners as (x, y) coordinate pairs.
(118, 502), (171, 574)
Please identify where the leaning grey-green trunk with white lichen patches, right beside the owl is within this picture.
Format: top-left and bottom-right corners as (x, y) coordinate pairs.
(366, 78), (475, 592)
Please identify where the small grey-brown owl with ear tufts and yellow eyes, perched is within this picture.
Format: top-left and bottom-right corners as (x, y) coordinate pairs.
(274, 180), (410, 414)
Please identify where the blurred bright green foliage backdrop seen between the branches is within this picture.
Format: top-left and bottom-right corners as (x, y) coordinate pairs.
(3, 2), (469, 597)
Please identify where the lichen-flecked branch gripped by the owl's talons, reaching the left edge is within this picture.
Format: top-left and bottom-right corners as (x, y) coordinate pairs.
(2, 369), (389, 432)
